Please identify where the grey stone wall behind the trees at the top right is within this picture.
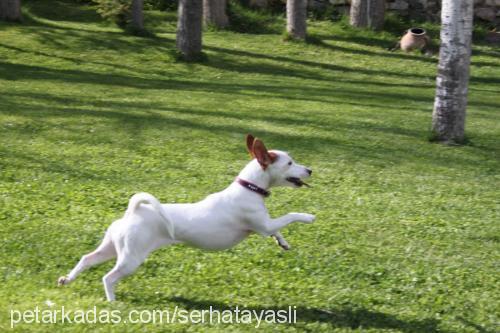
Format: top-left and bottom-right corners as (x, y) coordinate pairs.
(324, 0), (500, 25)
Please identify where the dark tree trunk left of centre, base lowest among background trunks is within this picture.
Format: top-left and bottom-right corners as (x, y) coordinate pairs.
(176, 0), (203, 60)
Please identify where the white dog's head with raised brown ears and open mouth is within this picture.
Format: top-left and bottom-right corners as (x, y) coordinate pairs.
(246, 134), (312, 187)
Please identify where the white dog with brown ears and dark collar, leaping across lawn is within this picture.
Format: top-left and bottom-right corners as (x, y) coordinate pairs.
(58, 135), (315, 301)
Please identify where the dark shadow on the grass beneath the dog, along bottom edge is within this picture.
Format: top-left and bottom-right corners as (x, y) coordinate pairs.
(140, 297), (445, 333)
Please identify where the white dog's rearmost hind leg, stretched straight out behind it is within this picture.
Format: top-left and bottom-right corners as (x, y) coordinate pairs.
(57, 234), (116, 286)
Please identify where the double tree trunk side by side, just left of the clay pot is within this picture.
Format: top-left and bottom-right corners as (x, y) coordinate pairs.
(351, 0), (385, 30)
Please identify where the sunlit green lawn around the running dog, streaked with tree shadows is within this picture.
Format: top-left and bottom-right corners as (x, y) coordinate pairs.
(0, 1), (500, 332)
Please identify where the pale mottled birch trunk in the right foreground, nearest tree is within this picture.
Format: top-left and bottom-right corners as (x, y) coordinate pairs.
(432, 0), (473, 143)
